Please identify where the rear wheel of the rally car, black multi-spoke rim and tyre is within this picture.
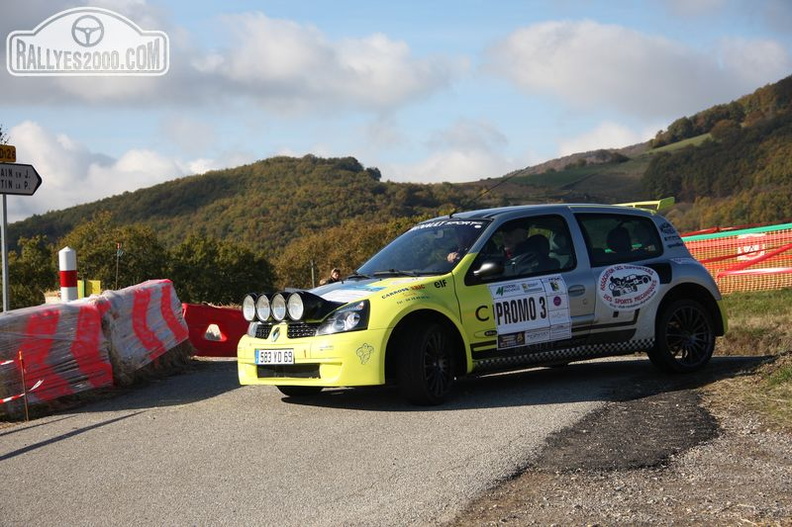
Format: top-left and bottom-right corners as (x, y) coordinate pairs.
(649, 299), (715, 373)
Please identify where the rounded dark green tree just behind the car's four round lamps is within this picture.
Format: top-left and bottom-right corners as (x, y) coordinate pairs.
(168, 234), (275, 305)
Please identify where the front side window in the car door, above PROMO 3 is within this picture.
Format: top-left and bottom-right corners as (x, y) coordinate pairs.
(471, 216), (576, 281)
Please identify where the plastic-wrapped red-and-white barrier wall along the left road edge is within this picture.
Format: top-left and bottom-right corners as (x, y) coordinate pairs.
(0, 280), (188, 412)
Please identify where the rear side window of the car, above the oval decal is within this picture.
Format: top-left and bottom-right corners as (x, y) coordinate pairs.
(577, 214), (663, 267)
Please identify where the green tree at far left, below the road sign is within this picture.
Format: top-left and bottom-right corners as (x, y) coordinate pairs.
(8, 235), (58, 309)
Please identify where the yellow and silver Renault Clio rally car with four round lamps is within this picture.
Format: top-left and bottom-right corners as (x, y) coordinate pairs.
(237, 204), (726, 405)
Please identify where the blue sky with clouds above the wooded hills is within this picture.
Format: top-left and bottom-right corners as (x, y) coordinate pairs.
(0, 0), (792, 221)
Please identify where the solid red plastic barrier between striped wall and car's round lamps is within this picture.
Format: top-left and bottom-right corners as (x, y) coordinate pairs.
(182, 304), (248, 357)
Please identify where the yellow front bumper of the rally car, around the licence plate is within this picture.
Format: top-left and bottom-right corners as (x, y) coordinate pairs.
(237, 324), (387, 387)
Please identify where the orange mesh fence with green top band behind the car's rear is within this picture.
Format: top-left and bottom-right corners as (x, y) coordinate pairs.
(682, 223), (792, 293)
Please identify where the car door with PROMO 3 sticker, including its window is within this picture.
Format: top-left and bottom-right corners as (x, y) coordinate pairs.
(457, 213), (594, 366)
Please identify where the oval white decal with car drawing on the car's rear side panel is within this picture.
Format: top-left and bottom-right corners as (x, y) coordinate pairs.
(597, 264), (660, 311)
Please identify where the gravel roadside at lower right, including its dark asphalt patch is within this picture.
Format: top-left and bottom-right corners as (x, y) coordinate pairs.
(448, 358), (792, 527)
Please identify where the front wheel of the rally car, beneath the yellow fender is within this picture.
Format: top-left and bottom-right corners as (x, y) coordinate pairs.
(396, 322), (454, 406)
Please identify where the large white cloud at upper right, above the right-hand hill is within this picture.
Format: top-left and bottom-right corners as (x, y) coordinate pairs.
(486, 21), (792, 118)
